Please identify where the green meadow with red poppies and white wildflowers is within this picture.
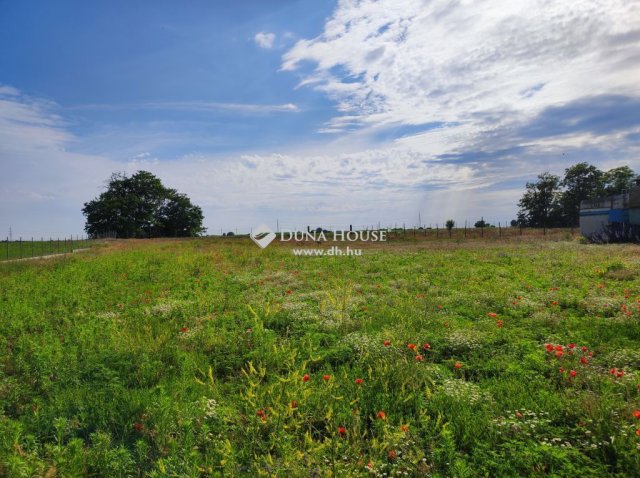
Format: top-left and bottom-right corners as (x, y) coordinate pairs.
(0, 238), (640, 478)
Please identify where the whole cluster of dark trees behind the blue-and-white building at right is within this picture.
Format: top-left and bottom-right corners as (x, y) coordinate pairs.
(512, 162), (640, 227)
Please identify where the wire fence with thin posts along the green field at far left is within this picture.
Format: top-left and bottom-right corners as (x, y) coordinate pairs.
(0, 235), (92, 261)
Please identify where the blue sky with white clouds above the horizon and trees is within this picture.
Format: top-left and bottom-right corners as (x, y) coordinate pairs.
(0, 0), (640, 238)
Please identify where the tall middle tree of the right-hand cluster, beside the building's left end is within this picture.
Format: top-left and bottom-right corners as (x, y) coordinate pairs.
(560, 163), (604, 226)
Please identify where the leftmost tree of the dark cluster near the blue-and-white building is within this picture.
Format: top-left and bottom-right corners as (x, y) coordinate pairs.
(518, 172), (562, 227)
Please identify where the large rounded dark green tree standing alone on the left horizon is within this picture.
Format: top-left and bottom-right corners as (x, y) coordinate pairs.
(82, 171), (205, 238)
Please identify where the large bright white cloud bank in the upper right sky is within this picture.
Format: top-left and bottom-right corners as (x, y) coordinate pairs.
(282, 0), (640, 131)
